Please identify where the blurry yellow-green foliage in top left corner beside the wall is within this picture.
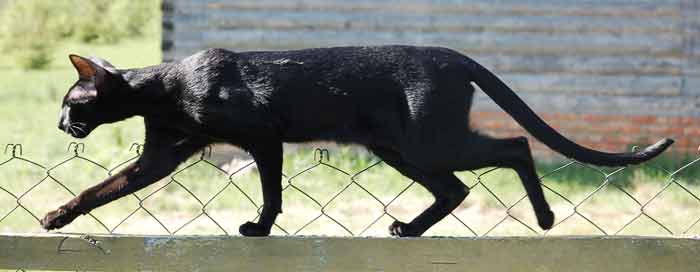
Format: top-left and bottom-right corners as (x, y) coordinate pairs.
(0, 0), (161, 69)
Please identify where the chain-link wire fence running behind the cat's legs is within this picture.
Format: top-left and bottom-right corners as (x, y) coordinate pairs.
(0, 143), (700, 237)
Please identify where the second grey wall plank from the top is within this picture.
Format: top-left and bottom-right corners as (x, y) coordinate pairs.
(172, 9), (681, 35)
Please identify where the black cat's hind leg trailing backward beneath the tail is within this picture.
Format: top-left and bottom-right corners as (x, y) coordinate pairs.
(455, 134), (554, 230)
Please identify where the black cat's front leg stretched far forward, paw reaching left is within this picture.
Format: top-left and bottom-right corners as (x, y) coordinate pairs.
(39, 130), (206, 230)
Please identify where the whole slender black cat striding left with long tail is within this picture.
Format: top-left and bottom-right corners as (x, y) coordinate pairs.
(41, 46), (673, 236)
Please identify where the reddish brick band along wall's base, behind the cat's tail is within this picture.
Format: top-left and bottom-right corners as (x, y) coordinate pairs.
(471, 112), (700, 157)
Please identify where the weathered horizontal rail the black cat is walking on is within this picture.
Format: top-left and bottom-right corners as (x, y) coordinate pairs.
(0, 234), (700, 272)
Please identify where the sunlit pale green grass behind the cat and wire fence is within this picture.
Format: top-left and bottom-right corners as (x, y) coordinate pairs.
(0, 31), (700, 236)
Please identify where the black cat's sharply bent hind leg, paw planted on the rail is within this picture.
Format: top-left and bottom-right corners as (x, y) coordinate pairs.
(372, 149), (469, 237)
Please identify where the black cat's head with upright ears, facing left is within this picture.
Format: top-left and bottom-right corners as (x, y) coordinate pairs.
(58, 55), (128, 138)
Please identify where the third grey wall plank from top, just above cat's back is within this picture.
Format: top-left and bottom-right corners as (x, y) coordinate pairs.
(183, 28), (683, 57)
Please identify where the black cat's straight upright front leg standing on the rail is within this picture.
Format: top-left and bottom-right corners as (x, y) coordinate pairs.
(238, 141), (282, 236)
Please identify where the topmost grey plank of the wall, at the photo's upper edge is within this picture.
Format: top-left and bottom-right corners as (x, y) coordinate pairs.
(200, 0), (680, 17)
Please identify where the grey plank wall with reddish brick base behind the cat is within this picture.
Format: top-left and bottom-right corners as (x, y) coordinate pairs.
(163, 0), (700, 155)
